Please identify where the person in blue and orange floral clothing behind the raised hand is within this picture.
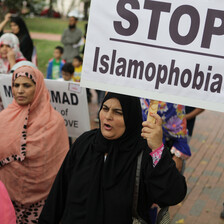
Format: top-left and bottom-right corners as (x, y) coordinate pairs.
(141, 98), (191, 224)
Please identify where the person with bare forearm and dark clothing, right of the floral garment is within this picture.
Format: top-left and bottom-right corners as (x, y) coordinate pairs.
(185, 106), (204, 141)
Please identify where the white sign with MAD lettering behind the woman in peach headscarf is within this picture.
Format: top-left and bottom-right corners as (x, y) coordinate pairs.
(0, 75), (90, 137)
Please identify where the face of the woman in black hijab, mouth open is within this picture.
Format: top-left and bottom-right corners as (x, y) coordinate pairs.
(99, 98), (125, 140)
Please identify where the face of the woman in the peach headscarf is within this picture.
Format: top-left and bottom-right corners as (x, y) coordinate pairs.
(12, 77), (36, 106)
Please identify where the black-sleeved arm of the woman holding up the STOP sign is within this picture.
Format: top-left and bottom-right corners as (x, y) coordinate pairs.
(144, 148), (187, 207)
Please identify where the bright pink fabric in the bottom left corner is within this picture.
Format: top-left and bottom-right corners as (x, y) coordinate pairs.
(0, 181), (16, 224)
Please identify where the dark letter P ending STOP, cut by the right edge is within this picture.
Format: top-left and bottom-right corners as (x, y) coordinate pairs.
(201, 9), (224, 48)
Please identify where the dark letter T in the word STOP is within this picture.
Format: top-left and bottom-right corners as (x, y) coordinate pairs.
(144, 0), (171, 40)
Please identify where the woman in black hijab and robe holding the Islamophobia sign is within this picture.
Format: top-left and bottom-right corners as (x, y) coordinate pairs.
(39, 93), (186, 224)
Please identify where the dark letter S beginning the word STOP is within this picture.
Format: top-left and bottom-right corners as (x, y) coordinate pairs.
(114, 0), (140, 36)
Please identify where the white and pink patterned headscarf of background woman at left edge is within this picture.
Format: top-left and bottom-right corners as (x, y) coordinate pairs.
(0, 33), (26, 74)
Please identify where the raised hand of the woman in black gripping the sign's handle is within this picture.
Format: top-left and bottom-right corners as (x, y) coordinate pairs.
(141, 114), (163, 151)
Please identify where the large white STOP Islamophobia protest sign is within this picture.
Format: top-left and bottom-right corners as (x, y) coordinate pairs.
(81, 0), (224, 111)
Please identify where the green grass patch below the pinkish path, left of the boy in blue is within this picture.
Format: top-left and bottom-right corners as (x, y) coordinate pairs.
(33, 39), (62, 77)
